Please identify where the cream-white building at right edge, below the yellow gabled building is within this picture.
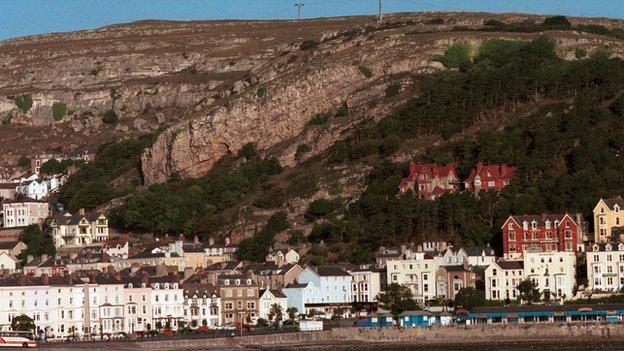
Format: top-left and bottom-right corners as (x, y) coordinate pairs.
(587, 243), (624, 292)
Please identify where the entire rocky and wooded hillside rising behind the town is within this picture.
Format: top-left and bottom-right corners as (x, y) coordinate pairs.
(6, 14), (624, 262)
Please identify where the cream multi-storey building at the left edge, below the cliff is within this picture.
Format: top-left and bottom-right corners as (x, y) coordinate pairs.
(2, 196), (50, 228)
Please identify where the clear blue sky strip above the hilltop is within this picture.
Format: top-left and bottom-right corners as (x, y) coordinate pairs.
(0, 0), (624, 40)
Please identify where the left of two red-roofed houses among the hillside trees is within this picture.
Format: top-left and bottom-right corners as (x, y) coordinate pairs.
(399, 162), (458, 200)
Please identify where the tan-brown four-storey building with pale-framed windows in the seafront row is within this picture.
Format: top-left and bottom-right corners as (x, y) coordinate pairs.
(217, 275), (259, 325)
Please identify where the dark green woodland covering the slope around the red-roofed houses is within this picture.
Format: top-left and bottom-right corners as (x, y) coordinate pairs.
(53, 24), (624, 263)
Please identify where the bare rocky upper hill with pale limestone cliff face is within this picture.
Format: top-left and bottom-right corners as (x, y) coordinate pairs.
(0, 14), (621, 177)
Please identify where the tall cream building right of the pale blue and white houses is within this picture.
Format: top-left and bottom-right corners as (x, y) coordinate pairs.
(386, 254), (438, 303)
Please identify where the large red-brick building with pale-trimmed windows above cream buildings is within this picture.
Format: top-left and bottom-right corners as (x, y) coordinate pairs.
(501, 213), (583, 258)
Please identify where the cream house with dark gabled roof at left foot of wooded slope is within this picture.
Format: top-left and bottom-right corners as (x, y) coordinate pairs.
(50, 209), (108, 248)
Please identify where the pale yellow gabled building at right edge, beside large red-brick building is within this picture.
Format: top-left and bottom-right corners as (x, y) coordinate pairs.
(593, 196), (624, 244)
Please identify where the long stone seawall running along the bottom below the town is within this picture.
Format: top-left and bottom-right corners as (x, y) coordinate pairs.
(39, 324), (624, 351)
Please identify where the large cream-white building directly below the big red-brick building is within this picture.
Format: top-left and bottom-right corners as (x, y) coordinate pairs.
(524, 252), (576, 300)
